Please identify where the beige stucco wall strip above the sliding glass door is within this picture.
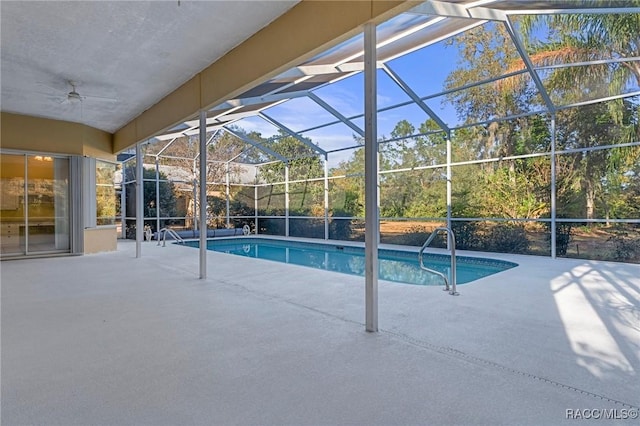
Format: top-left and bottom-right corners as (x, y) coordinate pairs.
(0, 112), (115, 160)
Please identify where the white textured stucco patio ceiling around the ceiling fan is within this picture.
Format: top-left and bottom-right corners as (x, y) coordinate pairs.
(0, 0), (298, 132)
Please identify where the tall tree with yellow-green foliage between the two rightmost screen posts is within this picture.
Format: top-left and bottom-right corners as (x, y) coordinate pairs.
(445, 24), (551, 218)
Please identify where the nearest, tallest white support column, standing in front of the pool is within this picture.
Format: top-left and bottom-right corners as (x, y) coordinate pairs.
(364, 23), (380, 332)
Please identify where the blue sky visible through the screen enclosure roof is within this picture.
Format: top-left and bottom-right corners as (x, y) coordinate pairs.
(235, 36), (457, 167)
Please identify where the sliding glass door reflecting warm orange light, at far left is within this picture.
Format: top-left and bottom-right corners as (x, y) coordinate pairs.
(0, 153), (70, 257)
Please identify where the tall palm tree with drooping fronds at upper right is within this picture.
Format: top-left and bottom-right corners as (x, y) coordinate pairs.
(506, 12), (640, 219)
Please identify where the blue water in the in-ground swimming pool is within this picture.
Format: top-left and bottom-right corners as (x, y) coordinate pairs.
(186, 237), (518, 285)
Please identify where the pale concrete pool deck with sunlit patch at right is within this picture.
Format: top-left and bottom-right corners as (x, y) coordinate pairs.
(0, 238), (640, 425)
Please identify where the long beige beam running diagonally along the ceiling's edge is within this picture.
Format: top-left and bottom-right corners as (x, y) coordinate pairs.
(114, 0), (420, 152)
